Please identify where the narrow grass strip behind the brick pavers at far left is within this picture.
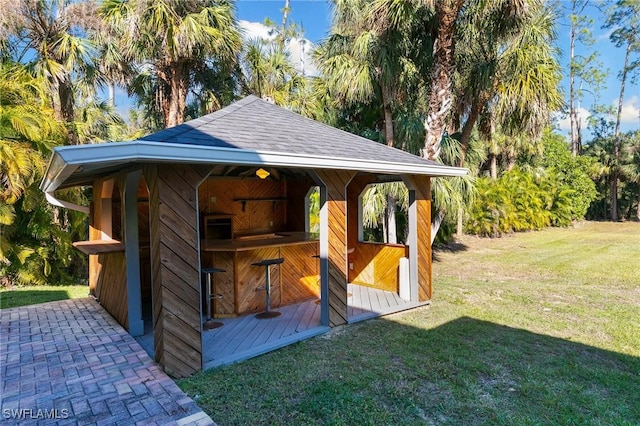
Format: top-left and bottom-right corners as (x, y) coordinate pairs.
(0, 285), (89, 309)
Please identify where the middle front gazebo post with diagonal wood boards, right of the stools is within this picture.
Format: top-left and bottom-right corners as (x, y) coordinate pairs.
(316, 170), (355, 327)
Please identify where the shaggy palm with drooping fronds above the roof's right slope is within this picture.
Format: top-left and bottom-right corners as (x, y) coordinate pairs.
(315, 0), (419, 146)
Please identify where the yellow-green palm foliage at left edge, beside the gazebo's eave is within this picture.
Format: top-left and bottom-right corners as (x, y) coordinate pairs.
(0, 62), (86, 284)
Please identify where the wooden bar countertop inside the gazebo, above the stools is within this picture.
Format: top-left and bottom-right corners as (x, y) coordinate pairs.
(200, 232), (318, 251)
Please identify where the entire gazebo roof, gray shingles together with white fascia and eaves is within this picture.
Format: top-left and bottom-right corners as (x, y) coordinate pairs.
(40, 96), (467, 193)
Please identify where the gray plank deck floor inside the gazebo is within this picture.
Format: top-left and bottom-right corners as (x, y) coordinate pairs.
(136, 284), (428, 370)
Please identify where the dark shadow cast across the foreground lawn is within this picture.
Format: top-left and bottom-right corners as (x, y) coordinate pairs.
(180, 311), (640, 425)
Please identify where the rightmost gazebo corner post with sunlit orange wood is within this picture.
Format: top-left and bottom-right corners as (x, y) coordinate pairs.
(402, 175), (431, 302)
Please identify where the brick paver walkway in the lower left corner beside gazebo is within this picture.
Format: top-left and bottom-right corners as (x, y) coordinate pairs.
(0, 298), (214, 426)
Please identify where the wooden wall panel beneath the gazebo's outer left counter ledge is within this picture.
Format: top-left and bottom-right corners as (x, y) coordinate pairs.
(94, 252), (129, 330)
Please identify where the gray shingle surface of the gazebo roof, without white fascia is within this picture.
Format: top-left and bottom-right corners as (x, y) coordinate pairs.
(141, 95), (442, 167)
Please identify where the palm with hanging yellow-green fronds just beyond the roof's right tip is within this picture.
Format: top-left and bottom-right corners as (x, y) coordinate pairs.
(454, 2), (562, 166)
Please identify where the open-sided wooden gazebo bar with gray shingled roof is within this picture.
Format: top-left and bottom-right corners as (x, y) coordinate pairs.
(41, 96), (467, 377)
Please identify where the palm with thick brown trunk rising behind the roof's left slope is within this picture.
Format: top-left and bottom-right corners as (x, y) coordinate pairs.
(100, 0), (241, 127)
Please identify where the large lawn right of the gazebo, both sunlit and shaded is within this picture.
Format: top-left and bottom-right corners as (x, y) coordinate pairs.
(178, 223), (640, 425)
